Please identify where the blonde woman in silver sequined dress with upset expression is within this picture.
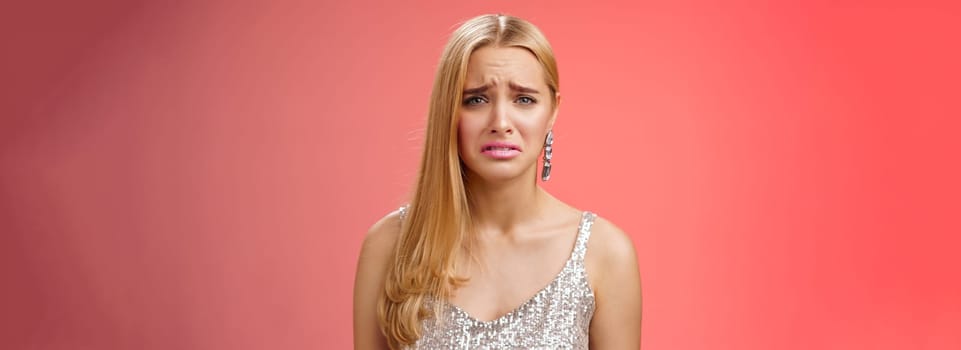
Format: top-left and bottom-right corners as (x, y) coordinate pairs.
(354, 15), (641, 349)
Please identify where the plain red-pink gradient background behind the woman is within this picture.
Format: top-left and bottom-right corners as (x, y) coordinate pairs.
(0, 1), (961, 349)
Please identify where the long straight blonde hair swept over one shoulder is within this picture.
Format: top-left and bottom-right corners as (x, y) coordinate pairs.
(377, 14), (559, 349)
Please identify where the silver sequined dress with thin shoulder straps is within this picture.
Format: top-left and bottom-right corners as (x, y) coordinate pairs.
(401, 208), (595, 349)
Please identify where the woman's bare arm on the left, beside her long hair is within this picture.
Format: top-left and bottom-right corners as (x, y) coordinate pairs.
(354, 212), (400, 350)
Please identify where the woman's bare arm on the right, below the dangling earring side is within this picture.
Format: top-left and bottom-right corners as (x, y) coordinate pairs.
(586, 218), (641, 350)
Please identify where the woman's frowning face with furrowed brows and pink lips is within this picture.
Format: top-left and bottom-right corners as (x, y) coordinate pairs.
(458, 46), (560, 182)
